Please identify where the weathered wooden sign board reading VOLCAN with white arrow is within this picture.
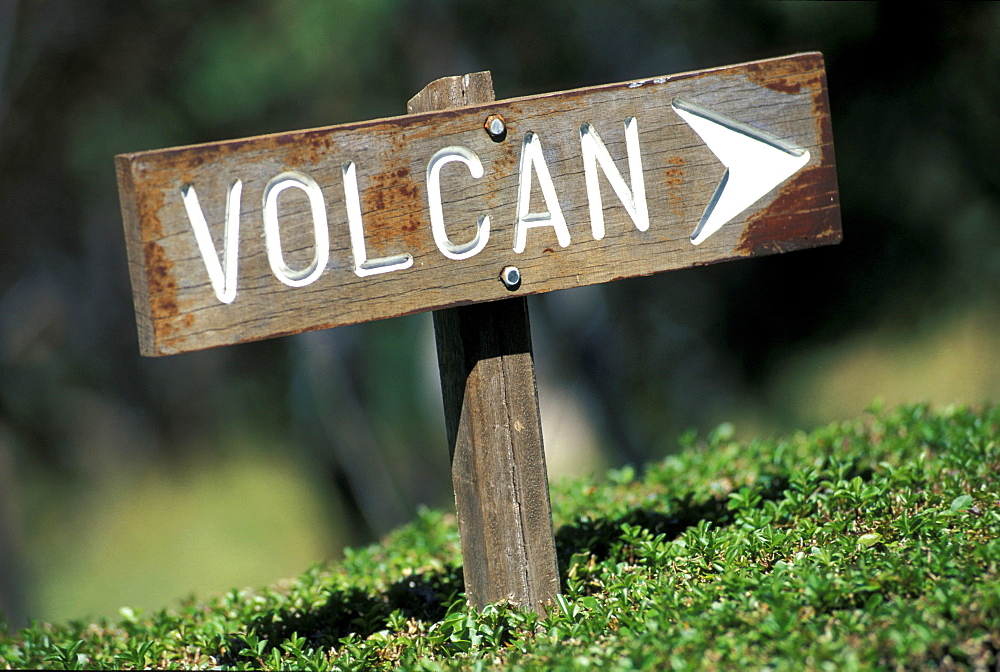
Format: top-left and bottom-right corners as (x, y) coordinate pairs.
(117, 53), (841, 355)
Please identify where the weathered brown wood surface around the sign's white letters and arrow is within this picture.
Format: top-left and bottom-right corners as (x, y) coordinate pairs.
(116, 53), (841, 355)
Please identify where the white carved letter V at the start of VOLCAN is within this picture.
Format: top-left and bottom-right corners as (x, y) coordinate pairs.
(181, 180), (243, 303)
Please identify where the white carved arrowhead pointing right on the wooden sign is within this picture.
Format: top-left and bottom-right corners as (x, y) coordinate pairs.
(671, 98), (809, 245)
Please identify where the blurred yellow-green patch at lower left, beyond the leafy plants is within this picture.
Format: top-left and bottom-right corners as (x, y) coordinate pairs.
(27, 442), (350, 616)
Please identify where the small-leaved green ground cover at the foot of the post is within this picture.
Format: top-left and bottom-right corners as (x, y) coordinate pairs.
(0, 406), (1000, 670)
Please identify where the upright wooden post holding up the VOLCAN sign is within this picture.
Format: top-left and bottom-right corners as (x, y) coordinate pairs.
(407, 72), (559, 613)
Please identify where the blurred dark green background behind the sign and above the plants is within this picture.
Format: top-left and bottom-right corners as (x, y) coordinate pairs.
(0, 0), (1000, 625)
